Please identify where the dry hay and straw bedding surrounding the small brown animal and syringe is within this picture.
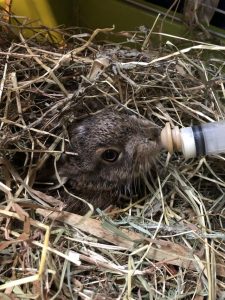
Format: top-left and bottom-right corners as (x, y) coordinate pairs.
(0, 9), (225, 299)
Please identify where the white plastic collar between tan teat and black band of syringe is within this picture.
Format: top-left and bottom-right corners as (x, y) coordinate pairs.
(180, 127), (196, 159)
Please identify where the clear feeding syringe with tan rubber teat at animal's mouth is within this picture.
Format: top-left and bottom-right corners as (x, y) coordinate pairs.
(161, 121), (225, 159)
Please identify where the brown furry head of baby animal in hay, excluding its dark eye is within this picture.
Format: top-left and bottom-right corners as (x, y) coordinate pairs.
(54, 109), (161, 214)
